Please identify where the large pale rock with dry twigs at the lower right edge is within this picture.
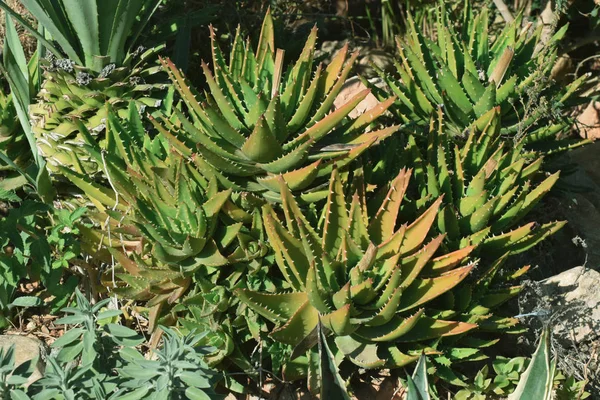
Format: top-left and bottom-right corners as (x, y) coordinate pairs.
(519, 267), (600, 398)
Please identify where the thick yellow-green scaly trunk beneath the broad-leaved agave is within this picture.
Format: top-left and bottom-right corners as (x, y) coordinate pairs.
(30, 49), (168, 175)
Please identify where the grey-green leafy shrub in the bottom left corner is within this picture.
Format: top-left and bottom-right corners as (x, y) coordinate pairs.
(0, 290), (222, 400)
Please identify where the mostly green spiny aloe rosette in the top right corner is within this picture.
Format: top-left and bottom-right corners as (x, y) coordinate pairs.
(372, 2), (587, 151)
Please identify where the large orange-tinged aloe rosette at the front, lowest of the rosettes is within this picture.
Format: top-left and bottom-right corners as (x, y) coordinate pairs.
(236, 170), (477, 379)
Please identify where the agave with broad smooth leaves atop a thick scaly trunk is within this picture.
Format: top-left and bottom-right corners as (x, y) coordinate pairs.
(0, 0), (168, 174)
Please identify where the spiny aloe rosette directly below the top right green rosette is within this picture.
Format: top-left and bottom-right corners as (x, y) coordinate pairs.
(402, 107), (565, 259)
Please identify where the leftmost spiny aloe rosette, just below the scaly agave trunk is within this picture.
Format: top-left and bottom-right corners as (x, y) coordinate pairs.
(61, 103), (253, 329)
